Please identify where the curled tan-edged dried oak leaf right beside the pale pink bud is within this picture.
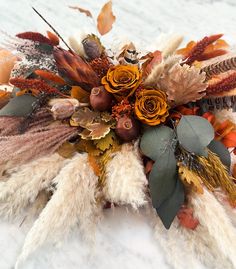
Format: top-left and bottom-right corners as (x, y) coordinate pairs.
(70, 107), (100, 128)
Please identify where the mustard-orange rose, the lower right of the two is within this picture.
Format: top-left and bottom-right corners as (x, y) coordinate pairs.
(134, 89), (169, 126)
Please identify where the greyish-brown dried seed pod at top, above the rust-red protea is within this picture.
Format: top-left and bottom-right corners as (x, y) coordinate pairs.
(82, 35), (104, 60)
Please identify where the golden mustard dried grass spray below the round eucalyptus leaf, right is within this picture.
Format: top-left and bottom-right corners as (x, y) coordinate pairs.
(198, 150), (236, 205)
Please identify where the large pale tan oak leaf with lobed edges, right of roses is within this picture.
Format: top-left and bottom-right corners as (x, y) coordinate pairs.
(159, 64), (207, 105)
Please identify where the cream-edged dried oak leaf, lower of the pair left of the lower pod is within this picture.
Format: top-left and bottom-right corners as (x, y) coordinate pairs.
(80, 121), (110, 140)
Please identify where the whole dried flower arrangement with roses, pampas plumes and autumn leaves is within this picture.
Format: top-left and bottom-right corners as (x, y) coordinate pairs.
(0, 1), (236, 268)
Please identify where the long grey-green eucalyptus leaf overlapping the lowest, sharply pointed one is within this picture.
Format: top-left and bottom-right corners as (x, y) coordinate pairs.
(149, 151), (176, 208)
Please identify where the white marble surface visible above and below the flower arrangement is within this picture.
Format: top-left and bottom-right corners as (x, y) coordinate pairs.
(0, 0), (236, 269)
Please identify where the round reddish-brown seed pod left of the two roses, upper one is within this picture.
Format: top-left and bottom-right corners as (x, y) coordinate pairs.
(89, 86), (113, 111)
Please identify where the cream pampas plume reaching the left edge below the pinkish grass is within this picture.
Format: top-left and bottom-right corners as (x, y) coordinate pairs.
(0, 153), (67, 218)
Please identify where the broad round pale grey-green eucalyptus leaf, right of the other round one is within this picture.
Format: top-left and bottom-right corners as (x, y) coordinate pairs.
(176, 116), (214, 156)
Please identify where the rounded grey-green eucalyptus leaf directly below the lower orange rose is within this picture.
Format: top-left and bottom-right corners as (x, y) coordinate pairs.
(140, 126), (176, 161)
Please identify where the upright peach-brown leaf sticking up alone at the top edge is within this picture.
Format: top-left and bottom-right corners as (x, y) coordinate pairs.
(97, 1), (116, 35)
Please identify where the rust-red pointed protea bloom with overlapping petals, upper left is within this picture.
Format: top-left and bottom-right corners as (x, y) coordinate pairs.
(53, 48), (99, 89)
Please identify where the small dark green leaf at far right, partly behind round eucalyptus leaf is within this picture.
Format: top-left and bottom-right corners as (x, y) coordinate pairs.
(208, 140), (231, 169)
